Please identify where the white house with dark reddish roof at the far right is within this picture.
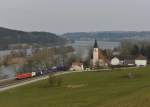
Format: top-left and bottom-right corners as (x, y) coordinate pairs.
(135, 54), (147, 67)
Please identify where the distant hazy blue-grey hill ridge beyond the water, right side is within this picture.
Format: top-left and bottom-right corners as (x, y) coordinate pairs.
(62, 31), (150, 42)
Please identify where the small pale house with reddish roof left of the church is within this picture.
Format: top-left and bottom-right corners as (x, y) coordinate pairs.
(70, 62), (84, 71)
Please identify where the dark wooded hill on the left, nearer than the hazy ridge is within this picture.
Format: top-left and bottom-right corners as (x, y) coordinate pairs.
(0, 27), (67, 49)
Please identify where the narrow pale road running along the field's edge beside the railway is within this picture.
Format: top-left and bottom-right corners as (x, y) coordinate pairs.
(0, 71), (77, 92)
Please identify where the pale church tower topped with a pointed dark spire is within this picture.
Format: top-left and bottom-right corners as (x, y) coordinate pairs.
(93, 40), (99, 66)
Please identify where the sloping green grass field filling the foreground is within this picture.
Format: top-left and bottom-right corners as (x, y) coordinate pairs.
(0, 67), (150, 107)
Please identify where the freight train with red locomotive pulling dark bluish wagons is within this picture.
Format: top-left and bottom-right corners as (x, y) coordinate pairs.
(15, 65), (69, 80)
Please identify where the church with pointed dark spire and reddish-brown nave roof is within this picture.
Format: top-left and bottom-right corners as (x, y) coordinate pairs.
(92, 40), (108, 67)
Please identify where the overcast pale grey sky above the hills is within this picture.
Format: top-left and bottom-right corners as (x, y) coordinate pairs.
(0, 0), (150, 34)
